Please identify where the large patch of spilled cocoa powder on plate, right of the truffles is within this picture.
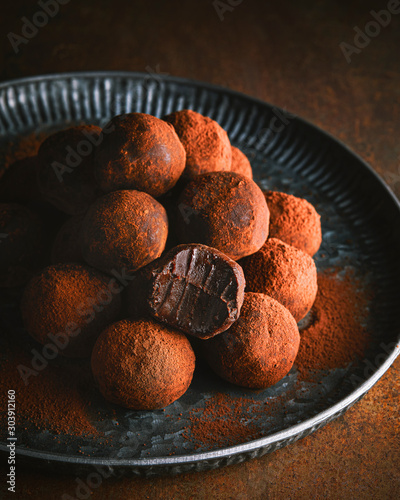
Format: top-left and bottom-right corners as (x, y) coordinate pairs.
(295, 269), (371, 380)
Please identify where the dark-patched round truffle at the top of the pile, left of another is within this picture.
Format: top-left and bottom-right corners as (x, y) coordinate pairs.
(95, 113), (186, 197)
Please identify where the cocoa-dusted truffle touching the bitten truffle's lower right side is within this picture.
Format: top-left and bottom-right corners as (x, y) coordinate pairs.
(201, 293), (300, 389)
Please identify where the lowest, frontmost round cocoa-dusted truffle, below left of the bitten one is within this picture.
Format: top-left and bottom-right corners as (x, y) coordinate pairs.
(91, 319), (195, 410)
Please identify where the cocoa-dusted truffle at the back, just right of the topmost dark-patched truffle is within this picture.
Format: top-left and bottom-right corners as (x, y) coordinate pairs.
(164, 109), (232, 179)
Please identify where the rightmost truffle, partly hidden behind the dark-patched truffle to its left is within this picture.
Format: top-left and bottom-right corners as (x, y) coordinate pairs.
(264, 191), (322, 257)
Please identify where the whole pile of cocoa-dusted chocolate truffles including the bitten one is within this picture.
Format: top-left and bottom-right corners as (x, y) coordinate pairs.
(0, 110), (321, 410)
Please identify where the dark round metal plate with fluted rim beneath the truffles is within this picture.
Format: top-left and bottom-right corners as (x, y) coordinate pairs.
(0, 72), (400, 476)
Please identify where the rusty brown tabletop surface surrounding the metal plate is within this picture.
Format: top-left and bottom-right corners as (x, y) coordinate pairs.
(0, 0), (400, 500)
